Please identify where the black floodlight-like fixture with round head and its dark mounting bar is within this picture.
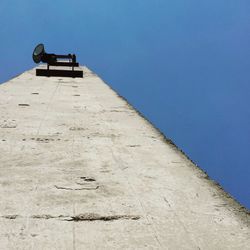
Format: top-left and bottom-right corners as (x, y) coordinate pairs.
(32, 43), (83, 77)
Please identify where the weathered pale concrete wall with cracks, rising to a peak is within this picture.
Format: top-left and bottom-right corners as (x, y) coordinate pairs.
(0, 65), (250, 249)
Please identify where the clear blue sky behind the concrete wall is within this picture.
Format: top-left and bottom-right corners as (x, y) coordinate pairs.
(0, 0), (250, 208)
